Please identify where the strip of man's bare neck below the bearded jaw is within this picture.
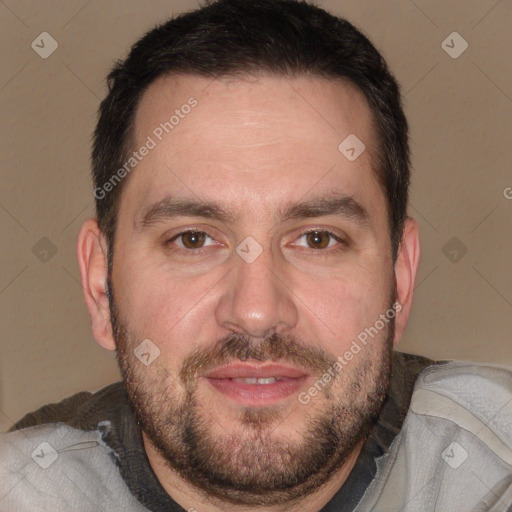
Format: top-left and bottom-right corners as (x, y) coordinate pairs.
(142, 433), (364, 512)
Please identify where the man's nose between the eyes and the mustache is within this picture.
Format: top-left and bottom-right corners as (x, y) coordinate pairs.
(216, 245), (298, 338)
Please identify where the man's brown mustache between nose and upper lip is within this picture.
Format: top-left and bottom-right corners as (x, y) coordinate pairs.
(179, 333), (336, 389)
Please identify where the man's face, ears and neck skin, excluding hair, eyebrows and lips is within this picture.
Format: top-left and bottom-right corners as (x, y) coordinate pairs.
(78, 75), (419, 511)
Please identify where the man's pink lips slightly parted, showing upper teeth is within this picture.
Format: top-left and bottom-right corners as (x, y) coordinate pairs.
(203, 363), (309, 406)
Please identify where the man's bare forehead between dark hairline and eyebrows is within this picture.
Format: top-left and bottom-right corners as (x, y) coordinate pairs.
(121, 71), (383, 222)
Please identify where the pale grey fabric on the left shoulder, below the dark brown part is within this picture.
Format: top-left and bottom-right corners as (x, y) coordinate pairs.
(0, 423), (146, 512)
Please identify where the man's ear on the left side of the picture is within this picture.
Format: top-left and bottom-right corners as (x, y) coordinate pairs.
(76, 219), (116, 350)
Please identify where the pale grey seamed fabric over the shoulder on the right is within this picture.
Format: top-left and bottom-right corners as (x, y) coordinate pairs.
(357, 362), (512, 512)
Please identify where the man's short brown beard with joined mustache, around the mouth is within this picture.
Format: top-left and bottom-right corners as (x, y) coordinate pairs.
(111, 284), (395, 506)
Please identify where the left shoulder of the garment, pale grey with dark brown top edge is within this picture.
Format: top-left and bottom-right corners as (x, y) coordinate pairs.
(0, 382), (150, 512)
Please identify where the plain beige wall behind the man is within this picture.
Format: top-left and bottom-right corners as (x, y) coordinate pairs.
(0, 0), (512, 429)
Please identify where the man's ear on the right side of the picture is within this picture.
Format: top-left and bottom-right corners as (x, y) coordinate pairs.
(393, 217), (420, 345)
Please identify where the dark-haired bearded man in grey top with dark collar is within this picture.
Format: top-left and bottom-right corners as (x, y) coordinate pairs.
(0, 0), (512, 512)
